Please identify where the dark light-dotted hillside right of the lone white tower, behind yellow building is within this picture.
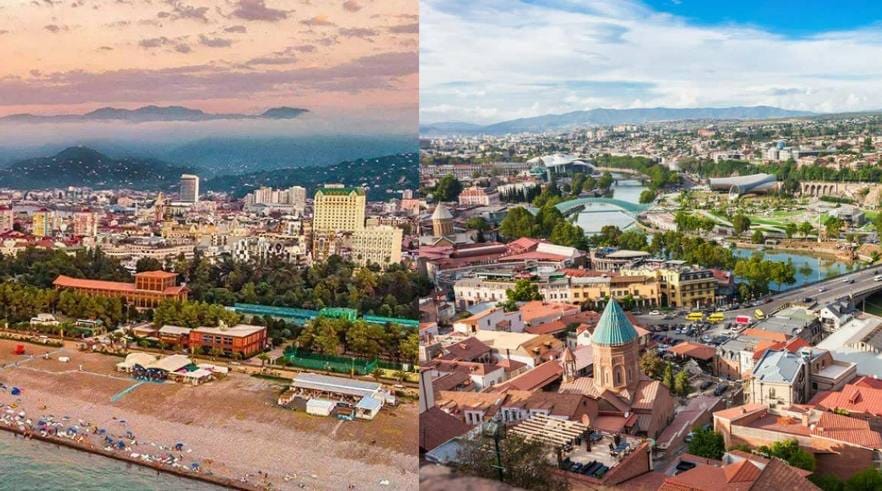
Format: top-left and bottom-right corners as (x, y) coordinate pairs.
(203, 153), (419, 200)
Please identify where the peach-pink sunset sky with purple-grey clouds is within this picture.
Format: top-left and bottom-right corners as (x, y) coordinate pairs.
(0, 0), (419, 127)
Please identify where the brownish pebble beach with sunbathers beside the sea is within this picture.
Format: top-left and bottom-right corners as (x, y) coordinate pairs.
(0, 340), (419, 489)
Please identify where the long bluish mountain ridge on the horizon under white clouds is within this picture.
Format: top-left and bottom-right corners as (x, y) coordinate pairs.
(420, 106), (814, 136)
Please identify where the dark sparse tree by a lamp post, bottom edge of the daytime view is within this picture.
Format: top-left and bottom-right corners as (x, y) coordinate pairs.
(455, 435), (568, 491)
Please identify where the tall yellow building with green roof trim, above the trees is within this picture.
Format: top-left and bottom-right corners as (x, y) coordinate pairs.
(312, 185), (367, 234)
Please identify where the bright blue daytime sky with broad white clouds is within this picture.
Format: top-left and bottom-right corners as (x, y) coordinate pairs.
(420, 0), (882, 123)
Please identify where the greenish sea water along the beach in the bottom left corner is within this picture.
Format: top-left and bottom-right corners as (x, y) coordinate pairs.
(0, 431), (224, 491)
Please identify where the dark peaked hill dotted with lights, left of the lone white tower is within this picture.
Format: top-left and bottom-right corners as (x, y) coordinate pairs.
(0, 147), (193, 190)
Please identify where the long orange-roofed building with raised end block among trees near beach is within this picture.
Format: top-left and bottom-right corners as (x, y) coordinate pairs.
(52, 271), (189, 308)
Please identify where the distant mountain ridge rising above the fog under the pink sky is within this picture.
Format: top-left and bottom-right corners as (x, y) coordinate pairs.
(0, 105), (309, 123)
